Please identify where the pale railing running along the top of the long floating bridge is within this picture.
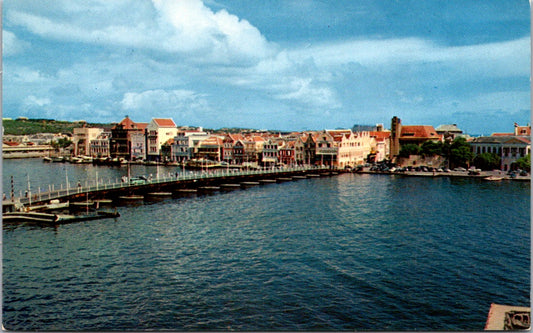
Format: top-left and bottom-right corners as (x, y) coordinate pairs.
(14, 166), (321, 204)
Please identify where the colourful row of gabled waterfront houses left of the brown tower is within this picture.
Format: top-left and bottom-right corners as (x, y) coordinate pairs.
(72, 116), (390, 167)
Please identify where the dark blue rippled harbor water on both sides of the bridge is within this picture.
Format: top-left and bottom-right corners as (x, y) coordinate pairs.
(2, 160), (531, 331)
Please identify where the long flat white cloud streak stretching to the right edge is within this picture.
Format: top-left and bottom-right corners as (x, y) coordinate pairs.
(284, 37), (530, 76)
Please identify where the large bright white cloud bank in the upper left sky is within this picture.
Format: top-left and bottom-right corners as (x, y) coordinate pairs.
(6, 0), (273, 65)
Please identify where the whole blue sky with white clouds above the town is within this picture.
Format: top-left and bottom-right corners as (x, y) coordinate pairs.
(2, 0), (531, 134)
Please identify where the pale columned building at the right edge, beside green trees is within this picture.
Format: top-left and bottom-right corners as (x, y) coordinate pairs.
(470, 124), (531, 171)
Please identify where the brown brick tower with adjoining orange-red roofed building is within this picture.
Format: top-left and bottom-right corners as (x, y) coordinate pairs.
(390, 116), (442, 162)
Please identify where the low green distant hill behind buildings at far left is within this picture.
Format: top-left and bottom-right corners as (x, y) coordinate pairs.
(2, 119), (113, 135)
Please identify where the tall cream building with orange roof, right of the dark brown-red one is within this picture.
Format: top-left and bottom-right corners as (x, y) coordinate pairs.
(146, 118), (178, 161)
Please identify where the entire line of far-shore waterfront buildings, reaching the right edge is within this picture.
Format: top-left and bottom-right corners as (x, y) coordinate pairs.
(69, 116), (531, 170)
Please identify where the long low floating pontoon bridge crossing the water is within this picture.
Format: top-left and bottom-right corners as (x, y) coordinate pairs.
(2, 166), (336, 211)
